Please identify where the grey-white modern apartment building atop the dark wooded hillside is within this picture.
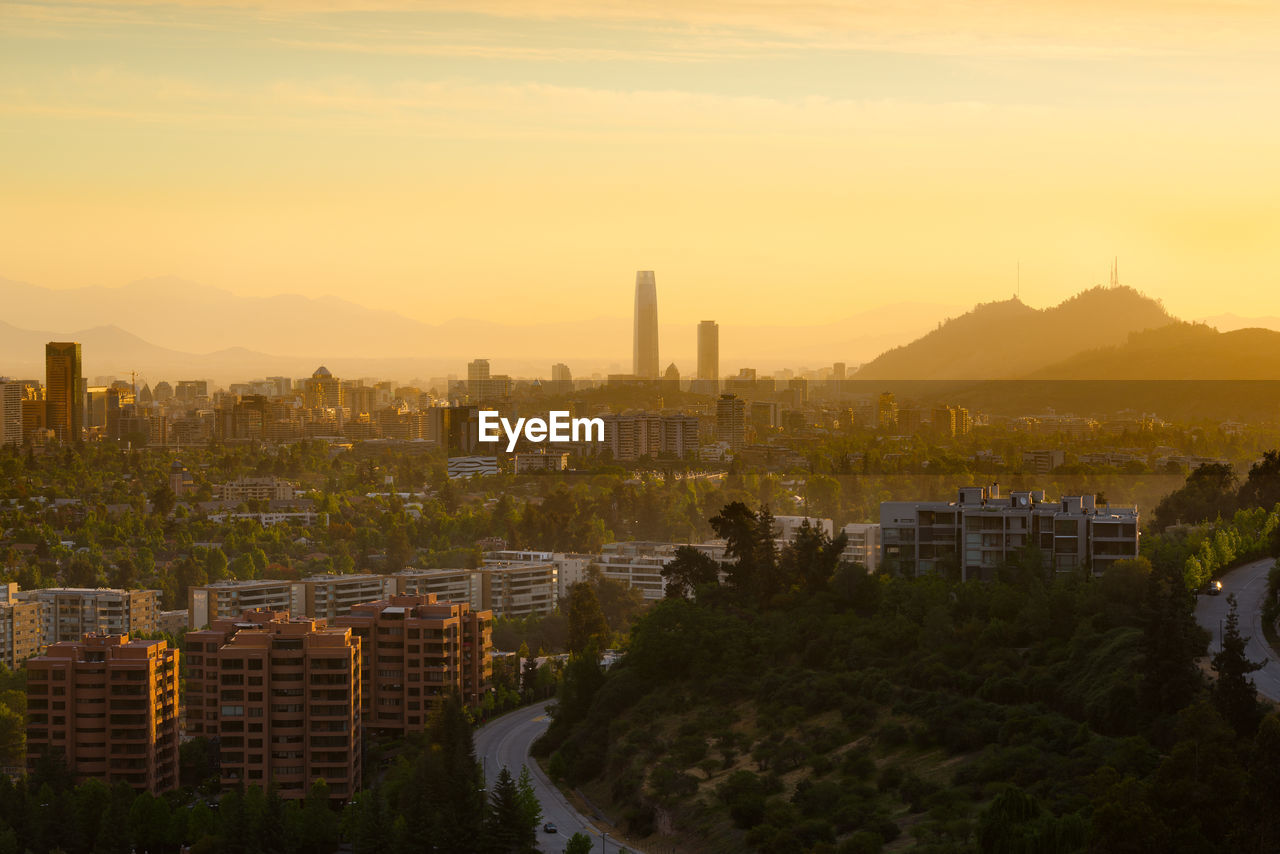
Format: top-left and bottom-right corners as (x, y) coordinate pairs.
(881, 485), (1139, 579)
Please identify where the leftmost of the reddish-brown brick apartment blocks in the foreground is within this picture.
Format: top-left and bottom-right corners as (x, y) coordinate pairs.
(27, 635), (178, 794)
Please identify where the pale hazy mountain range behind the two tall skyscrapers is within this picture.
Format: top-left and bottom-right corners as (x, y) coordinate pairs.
(0, 278), (957, 379)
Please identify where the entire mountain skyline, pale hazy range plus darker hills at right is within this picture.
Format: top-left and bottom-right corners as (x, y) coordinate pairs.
(0, 279), (1280, 398)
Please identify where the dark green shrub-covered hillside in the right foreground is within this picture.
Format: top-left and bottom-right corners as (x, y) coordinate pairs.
(536, 504), (1280, 853)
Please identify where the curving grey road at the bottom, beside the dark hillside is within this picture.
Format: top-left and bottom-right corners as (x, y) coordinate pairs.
(475, 703), (629, 854)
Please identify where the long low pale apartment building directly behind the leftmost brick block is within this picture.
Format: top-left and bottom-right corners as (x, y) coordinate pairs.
(17, 588), (160, 647)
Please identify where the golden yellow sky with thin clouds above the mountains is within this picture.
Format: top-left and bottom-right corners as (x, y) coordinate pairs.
(0, 0), (1280, 326)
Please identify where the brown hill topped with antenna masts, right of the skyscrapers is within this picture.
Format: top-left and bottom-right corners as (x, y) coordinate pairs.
(855, 287), (1174, 380)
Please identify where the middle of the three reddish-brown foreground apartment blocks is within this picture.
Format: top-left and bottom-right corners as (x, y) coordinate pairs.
(186, 611), (362, 800)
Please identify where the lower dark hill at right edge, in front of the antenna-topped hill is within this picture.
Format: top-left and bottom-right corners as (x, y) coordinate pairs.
(1025, 323), (1280, 380)
